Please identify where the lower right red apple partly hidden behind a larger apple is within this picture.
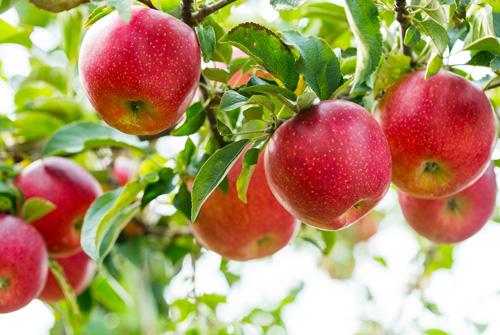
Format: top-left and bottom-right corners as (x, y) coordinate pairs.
(399, 164), (497, 244)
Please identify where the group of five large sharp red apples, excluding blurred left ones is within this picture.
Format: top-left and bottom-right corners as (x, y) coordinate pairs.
(79, 6), (496, 260)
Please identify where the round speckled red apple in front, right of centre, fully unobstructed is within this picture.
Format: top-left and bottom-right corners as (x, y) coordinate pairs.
(264, 100), (391, 230)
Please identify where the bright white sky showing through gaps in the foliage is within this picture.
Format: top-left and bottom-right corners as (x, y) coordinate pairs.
(0, 1), (500, 335)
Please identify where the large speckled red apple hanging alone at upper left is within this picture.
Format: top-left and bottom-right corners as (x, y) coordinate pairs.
(79, 6), (201, 135)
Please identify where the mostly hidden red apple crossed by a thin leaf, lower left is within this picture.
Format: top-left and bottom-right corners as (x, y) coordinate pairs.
(38, 251), (96, 303)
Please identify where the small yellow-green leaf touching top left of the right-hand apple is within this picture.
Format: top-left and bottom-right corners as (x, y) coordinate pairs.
(373, 55), (411, 97)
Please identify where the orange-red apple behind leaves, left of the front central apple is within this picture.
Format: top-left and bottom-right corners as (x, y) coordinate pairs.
(190, 151), (299, 261)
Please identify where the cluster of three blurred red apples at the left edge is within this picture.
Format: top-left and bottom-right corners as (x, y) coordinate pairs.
(0, 157), (102, 313)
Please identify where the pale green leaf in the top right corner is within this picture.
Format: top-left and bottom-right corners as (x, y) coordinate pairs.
(463, 5), (500, 53)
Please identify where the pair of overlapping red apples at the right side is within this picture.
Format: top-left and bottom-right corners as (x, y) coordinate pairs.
(376, 71), (497, 243)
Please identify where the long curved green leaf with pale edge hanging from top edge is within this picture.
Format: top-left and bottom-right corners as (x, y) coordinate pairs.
(345, 0), (382, 92)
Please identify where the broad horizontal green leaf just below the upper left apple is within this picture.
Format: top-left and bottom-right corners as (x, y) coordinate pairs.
(42, 121), (148, 156)
